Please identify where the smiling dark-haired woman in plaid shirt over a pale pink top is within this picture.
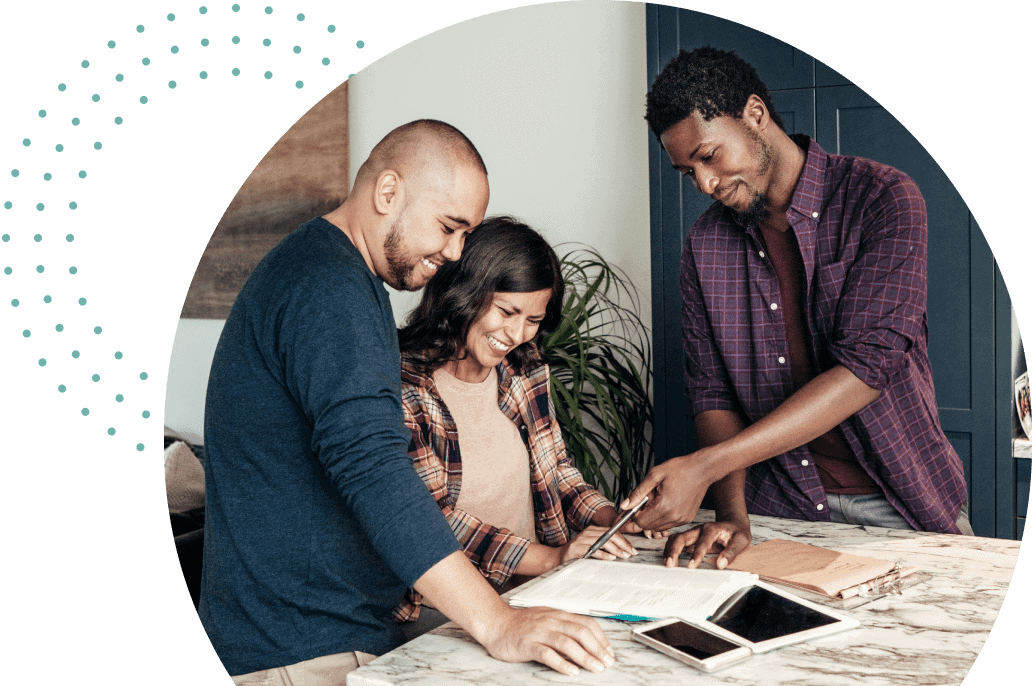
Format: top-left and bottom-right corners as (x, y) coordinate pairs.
(395, 217), (639, 633)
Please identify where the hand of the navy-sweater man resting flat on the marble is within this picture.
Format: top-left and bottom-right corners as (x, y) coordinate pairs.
(481, 607), (614, 677)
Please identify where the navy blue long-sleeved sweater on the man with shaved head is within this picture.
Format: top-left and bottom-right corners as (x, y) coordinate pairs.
(199, 218), (458, 675)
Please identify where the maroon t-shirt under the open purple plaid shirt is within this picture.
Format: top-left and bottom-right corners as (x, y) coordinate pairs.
(758, 220), (882, 496)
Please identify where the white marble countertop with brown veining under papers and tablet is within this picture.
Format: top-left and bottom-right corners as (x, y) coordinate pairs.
(347, 512), (1020, 686)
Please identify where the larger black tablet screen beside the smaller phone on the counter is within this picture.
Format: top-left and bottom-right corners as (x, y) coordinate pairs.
(709, 586), (839, 644)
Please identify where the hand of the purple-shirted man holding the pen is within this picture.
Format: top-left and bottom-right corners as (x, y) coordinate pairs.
(621, 452), (711, 531)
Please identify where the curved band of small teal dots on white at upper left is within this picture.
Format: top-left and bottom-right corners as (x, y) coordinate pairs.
(0, 3), (365, 459)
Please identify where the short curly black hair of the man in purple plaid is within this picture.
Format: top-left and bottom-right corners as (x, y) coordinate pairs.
(646, 46), (786, 138)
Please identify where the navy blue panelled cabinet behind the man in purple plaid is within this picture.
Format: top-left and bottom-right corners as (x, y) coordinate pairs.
(646, 5), (1030, 538)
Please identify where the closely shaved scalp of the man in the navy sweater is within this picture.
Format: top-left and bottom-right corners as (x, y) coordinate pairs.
(355, 119), (488, 195)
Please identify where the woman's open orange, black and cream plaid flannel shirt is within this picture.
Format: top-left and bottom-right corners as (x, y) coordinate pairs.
(392, 355), (611, 622)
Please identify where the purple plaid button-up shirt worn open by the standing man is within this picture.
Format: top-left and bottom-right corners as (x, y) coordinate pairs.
(681, 132), (966, 533)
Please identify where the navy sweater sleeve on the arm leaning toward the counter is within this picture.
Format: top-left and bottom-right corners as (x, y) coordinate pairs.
(276, 260), (458, 587)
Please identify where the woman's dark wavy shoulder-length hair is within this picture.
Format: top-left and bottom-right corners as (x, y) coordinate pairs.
(398, 216), (564, 374)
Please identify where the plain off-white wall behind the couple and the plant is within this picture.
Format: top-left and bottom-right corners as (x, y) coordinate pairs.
(165, 0), (650, 437)
